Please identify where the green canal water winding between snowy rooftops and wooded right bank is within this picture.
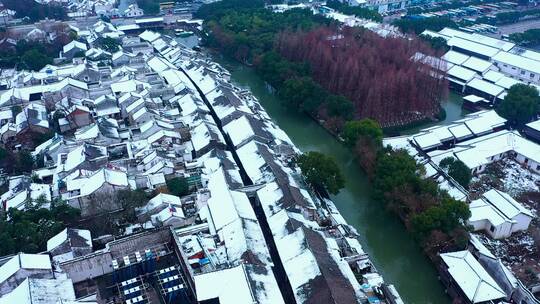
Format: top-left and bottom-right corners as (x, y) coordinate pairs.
(215, 58), (461, 304)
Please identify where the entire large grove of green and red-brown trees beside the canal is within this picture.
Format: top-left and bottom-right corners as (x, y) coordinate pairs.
(196, 0), (447, 133)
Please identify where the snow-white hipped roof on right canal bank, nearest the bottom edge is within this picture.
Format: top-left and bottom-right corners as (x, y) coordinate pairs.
(441, 250), (506, 303)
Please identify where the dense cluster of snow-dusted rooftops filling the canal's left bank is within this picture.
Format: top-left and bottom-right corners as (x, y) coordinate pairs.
(0, 17), (399, 303)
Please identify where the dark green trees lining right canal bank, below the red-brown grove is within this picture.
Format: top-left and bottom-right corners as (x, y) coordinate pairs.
(343, 119), (470, 256)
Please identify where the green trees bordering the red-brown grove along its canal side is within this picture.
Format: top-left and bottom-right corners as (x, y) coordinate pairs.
(197, 0), (354, 132)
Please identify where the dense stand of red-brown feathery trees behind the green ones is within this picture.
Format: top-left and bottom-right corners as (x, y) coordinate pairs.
(276, 27), (448, 127)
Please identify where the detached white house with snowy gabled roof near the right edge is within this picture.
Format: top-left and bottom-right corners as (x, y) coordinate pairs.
(469, 189), (534, 239)
